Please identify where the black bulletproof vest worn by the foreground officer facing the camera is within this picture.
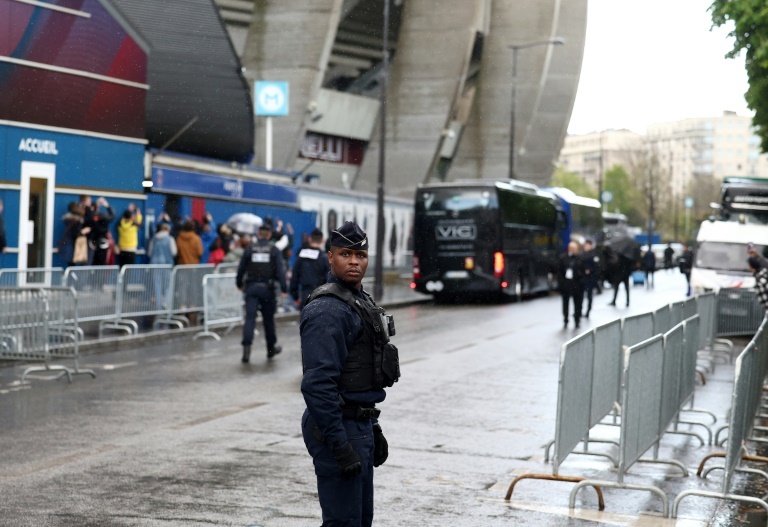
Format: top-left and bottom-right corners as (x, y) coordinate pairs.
(307, 283), (400, 392)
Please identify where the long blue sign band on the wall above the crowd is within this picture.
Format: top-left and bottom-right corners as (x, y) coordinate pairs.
(152, 167), (298, 206)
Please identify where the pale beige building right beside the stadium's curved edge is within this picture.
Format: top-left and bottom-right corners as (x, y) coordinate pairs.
(558, 130), (643, 188)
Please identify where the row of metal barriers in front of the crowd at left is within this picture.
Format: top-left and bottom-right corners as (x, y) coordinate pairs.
(0, 264), (243, 382)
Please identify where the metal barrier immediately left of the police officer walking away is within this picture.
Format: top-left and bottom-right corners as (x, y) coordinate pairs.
(195, 273), (244, 340)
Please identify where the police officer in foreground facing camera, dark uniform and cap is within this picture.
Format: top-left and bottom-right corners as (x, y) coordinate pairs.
(299, 222), (400, 527)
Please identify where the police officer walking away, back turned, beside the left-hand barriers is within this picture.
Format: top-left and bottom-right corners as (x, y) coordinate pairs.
(237, 222), (288, 362)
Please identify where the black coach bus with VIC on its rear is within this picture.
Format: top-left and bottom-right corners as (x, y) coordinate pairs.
(412, 180), (562, 299)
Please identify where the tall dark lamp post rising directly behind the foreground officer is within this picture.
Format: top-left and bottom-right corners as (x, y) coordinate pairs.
(373, 0), (389, 301)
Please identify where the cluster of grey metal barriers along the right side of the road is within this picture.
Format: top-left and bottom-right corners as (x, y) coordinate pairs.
(506, 290), (768, 517)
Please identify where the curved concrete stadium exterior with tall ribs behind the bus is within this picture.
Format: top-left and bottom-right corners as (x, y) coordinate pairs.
(222, 0), (587, 198)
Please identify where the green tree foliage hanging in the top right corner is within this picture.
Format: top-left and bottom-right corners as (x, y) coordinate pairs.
(709, 0), (768, 152)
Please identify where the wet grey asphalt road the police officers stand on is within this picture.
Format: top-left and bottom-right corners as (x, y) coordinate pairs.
(0, 272), (752, 527)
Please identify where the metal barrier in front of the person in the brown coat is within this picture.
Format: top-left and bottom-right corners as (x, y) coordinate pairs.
(153, 264), (214, 328)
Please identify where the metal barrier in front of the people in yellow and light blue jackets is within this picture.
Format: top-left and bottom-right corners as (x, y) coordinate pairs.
(99, 265), (173, 338)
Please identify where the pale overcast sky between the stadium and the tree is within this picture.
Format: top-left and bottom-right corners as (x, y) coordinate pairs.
(566, 0), (752, 134)
